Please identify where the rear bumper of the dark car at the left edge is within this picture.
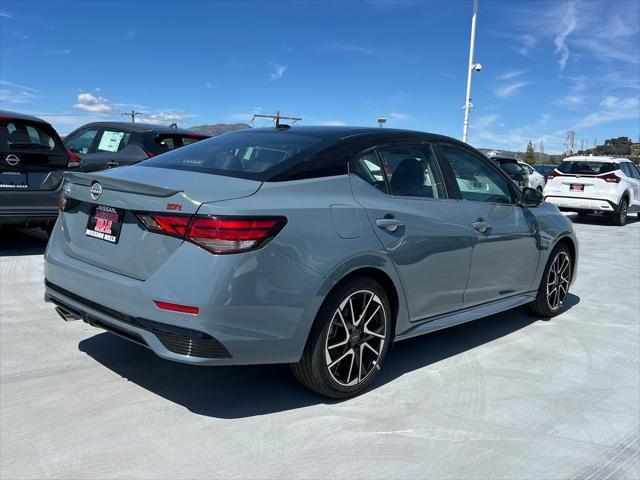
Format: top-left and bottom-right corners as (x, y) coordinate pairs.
(0, 184), (62, 227)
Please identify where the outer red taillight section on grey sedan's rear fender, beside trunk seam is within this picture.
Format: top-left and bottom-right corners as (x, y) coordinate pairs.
(187, 217), (286, 254)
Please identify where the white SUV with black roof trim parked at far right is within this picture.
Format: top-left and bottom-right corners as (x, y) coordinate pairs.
(543, 156), (640, 225)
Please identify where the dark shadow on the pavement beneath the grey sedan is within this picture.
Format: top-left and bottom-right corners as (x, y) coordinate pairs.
(79, 294), (580, 419)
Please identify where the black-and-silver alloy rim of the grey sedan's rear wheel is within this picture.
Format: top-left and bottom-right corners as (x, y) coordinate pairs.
(325, 290), (387, 387)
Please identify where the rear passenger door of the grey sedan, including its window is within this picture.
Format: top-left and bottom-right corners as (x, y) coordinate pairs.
(350, 143), (472, 321)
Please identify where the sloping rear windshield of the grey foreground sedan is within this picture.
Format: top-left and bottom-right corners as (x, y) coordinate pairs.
(141, 131), (322, 180)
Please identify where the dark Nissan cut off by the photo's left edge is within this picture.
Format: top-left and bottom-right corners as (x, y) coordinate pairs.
(0, 110), (80, 234)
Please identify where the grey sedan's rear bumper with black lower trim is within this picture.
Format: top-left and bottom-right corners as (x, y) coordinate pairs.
(45, 228), (323, 365)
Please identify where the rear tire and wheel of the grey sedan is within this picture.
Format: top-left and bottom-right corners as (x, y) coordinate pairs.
(291, 277), (394, 398)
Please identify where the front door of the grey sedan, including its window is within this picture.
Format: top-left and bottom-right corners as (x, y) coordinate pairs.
(439, 144), (539, 307)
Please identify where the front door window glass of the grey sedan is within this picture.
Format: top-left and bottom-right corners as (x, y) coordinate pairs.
(442, 145), (513, 203)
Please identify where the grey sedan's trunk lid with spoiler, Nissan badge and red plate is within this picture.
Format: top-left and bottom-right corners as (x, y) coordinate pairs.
(61, 166), (261, 280)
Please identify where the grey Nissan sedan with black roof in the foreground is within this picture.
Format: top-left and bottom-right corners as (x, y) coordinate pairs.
(45, 127), (578, 398)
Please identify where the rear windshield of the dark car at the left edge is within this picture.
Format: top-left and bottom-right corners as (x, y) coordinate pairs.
(0, 120), (63, 152)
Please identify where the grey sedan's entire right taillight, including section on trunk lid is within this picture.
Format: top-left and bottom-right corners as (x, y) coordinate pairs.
(136, 213), (287, 254)
